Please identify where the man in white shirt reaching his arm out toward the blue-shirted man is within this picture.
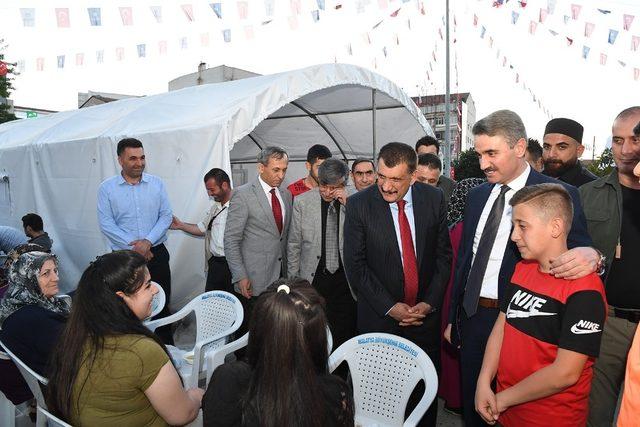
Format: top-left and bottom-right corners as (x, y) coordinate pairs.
(170, 168), (233, 293)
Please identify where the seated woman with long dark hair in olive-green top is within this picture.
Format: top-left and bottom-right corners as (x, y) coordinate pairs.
(47, 251), (204, 426)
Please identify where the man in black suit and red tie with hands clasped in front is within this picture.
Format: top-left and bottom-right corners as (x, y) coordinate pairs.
(344, 142), (451, 426)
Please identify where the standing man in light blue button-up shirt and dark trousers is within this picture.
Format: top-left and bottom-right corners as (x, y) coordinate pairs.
(98, 138), (172, 343)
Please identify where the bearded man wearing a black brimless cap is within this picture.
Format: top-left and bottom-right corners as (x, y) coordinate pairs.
(542, 118), (598, 187)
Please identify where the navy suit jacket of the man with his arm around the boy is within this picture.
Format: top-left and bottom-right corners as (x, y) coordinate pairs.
(449, 169), (592, 338)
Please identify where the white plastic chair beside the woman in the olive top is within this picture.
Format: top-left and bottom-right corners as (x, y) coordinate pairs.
(145, 291), (244, 388)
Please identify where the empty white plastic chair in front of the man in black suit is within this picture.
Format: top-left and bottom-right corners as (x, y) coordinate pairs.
(329, 333), (438, 427)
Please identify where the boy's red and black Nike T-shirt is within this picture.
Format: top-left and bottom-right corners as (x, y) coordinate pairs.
(497, 261), (606, 427)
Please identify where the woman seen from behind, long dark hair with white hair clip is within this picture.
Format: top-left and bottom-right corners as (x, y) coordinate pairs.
(202, 279), (354, 427)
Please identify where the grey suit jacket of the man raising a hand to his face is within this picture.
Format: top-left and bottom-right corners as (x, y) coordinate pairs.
(287, 188), (355, 298)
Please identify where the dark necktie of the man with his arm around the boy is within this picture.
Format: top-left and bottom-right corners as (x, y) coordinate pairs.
(462, 185), (510, 317)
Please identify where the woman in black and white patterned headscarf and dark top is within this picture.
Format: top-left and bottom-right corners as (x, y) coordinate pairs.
(0, 252), (71, 376)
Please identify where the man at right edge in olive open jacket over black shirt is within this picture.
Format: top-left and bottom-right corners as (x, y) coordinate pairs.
(580, 106), (640, 427)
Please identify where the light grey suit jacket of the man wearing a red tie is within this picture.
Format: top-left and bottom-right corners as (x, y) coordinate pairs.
(224, 177), (291, 295)
